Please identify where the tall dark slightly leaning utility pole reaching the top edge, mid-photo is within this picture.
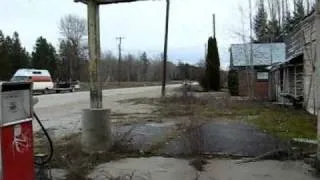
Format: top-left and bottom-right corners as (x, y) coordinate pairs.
(161, 0), (170, 97)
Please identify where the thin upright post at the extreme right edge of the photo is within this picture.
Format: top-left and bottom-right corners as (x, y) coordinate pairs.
(315, 0), (320, 172)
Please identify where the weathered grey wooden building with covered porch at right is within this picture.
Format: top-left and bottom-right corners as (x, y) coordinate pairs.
(269, 13), (316, 114)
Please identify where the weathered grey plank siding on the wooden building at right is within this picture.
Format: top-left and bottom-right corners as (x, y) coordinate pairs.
(285, 15), (316, 113)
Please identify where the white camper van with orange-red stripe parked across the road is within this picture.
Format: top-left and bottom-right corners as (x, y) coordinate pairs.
(11, 69), (54, 93)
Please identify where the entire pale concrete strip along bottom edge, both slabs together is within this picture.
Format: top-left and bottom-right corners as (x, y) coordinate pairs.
(88, 157), (317, 180)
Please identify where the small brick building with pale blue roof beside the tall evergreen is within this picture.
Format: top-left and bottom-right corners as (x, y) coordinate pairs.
(230, 43), (285, 99)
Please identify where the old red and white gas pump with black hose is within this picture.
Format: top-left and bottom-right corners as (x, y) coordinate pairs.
(0, 82), (52, 180)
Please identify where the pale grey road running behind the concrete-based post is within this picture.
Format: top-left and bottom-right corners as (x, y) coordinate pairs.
(34, 84), (180, 137)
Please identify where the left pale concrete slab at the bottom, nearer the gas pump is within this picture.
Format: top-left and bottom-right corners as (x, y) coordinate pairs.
(88, 157), (196, 180)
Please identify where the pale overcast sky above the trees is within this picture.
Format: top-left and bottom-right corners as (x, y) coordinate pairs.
(0, 0), (248, 66)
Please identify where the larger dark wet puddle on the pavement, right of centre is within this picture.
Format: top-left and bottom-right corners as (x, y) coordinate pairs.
(162, 122), (285, 157)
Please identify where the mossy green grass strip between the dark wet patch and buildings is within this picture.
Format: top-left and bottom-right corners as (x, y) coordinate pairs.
(127, 96), (317, 139)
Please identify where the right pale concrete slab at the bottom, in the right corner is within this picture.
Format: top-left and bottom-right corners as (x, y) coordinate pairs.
(202, 160), (318, 180)
